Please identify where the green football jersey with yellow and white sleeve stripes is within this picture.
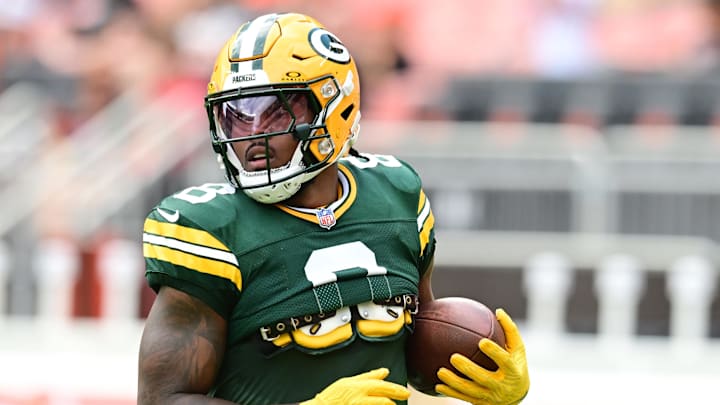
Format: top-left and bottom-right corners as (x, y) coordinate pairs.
(143, 154), (435, 404)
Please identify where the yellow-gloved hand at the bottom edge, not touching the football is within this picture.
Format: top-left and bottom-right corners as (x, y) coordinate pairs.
(300, 368), (410, 405)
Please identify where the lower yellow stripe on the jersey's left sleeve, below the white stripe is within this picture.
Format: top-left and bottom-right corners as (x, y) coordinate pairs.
(143, 243), (242, 291)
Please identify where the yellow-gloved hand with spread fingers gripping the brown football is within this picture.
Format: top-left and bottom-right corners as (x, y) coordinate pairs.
(435, 309), (530, 405)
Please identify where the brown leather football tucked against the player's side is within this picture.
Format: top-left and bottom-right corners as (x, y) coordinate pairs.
(406, 297), (505, 395)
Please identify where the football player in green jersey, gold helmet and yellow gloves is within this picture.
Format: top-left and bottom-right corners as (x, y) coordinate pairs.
(138, 13), (529, 405)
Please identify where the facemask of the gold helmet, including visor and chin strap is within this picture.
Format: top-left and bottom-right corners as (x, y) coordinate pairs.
(205, 78), (343, 204)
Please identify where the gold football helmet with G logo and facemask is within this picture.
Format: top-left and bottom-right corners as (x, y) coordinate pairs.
(205, 13), (360, 204)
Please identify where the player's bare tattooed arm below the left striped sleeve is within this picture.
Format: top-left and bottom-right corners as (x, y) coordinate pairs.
(138, 287), (231, 405)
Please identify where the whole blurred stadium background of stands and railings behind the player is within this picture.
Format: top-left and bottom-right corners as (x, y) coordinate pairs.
(0, 0), (720, 405)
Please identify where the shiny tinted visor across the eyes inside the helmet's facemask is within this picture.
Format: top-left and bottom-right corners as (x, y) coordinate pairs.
(213, 92), (318, 139)
